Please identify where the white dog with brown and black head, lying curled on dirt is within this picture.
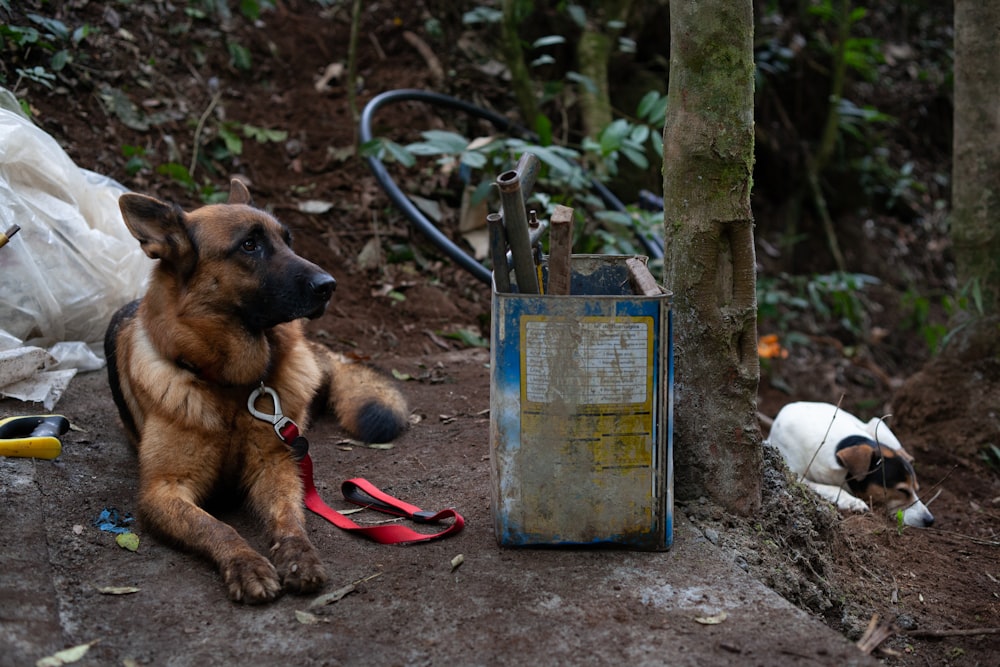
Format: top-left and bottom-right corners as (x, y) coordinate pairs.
(768, 402), (934, 528)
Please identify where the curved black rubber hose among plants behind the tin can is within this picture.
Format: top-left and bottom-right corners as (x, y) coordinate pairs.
(358, 88), (663, 283)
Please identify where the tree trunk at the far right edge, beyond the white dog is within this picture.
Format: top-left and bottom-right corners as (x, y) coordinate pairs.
(951, 0), (1000, 318)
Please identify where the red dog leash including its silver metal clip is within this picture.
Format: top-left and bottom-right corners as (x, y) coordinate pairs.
(247, 383), (465, 544)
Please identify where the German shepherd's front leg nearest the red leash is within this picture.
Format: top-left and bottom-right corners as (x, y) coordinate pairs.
(246, 452), (327, 593)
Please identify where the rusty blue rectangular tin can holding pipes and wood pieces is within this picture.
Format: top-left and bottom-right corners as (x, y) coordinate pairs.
(490, 255), (673, 551)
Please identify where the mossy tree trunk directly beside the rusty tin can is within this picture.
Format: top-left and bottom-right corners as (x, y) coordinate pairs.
(663, 0), (762, 515)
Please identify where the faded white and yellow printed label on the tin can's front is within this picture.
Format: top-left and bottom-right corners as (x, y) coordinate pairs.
(519, 315), (658, 541)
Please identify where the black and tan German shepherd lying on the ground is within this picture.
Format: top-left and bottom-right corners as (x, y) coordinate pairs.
(105, 180), (408, 603)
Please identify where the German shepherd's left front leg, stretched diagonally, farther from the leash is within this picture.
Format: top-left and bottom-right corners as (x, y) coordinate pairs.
(139, 476), (281, 604)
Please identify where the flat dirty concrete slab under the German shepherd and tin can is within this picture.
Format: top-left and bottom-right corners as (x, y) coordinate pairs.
(0, 368), (877, 666)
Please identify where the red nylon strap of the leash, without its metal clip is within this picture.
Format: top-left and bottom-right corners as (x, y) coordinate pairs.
(299, 454), (465, 544)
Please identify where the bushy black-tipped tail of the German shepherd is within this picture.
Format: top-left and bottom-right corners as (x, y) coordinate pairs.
(314, 345), (410, 442)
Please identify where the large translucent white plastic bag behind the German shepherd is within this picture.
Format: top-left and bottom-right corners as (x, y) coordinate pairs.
(0, 88), (152, 354)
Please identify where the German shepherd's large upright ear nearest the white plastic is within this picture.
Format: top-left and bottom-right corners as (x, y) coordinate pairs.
(118, 194), (193, 267)
